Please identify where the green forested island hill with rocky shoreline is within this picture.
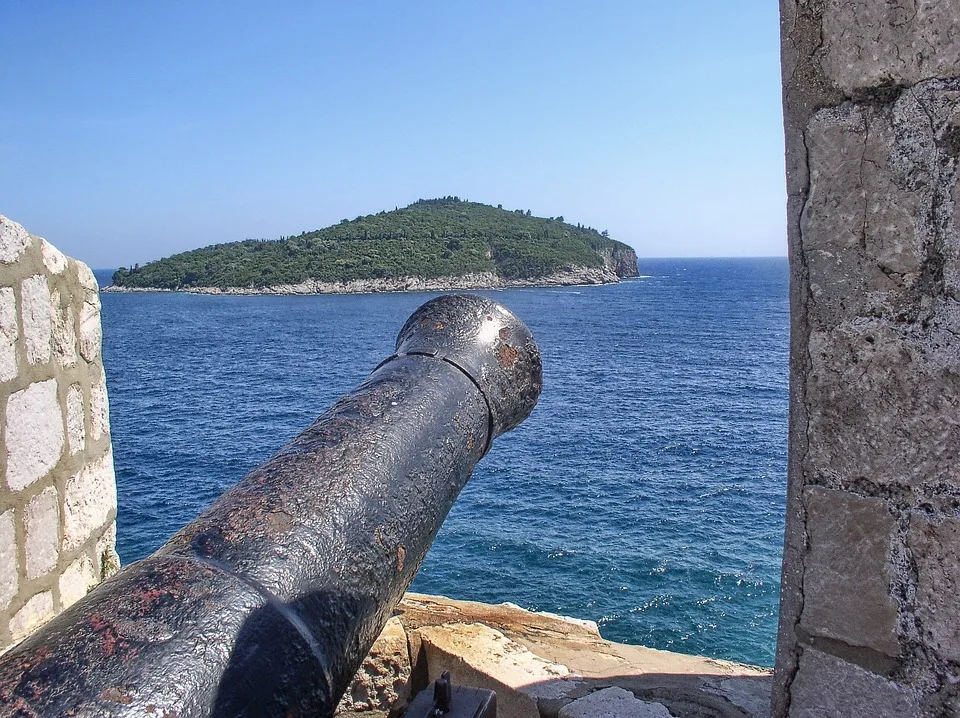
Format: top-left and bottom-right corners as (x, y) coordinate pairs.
(113, 197), (637, 289)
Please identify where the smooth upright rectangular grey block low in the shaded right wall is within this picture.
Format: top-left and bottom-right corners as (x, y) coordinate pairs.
(800, 486), (900, 656)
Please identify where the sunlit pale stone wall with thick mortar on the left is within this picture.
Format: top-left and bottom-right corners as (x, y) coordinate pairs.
(0, 215), (119, 651)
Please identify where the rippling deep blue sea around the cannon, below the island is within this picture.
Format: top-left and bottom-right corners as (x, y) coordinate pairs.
(99, 258), (789, 666)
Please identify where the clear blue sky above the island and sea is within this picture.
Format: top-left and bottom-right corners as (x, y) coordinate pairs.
(0, 0), (786, 267)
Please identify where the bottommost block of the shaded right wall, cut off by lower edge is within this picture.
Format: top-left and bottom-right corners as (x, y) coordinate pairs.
(789, 648), (922, 718)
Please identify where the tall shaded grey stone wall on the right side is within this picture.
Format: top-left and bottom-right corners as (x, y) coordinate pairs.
(773, 0), (960, 718)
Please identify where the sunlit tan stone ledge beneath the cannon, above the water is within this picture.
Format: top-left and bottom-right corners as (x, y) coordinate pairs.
(338, 593), (771, 718)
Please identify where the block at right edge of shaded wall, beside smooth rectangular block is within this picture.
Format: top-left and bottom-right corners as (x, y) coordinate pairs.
(907, 515), (960, 662)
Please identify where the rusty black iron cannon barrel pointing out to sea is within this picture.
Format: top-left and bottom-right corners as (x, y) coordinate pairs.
(0, 295), (542, 718)
